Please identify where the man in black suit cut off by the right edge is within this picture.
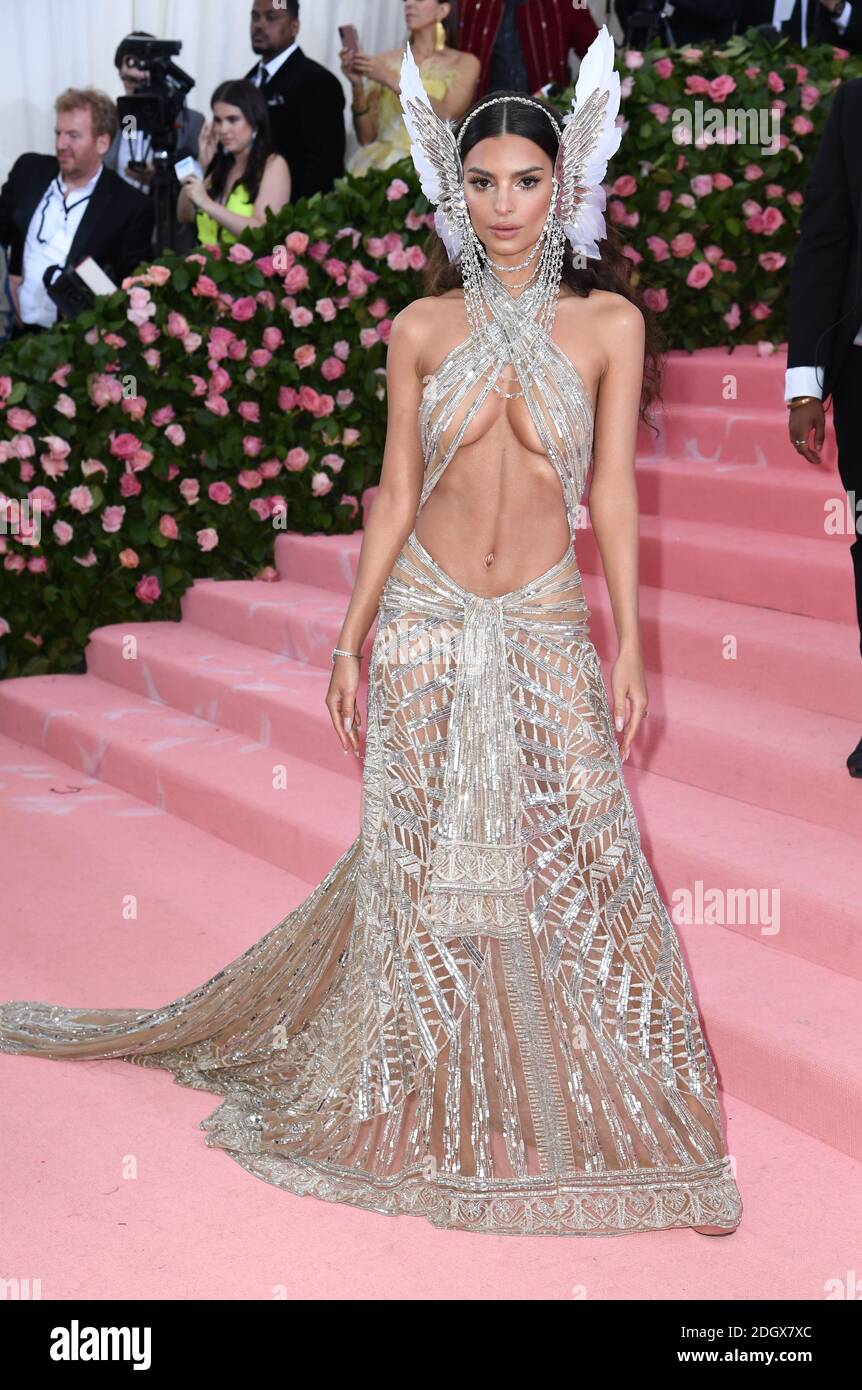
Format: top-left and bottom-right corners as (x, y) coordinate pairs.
(784, 78), (862, 777)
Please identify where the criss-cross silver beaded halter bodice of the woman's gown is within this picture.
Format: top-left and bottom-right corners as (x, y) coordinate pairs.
(418, 275), (594, 537)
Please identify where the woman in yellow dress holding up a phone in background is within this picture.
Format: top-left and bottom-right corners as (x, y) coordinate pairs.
(339, 0), (481, 174)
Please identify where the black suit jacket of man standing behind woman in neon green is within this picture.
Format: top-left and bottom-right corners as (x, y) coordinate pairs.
(246, 49), (346, 203)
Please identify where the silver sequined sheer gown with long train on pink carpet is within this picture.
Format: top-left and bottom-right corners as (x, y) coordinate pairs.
(0, 273), (741, 1236)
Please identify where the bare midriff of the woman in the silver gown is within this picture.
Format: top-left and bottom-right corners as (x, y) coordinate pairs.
(414, 296), (600, 598)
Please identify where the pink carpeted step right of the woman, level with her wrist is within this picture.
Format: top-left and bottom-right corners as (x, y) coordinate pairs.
(584, 574), (862, 722)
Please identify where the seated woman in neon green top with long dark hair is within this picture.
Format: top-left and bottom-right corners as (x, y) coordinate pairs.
(177, 78), (291, 246)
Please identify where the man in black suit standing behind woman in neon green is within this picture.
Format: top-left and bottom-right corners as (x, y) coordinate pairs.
(246, 0), (345, 203)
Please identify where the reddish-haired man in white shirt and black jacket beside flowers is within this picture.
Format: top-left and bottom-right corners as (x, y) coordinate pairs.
(0, 88), (153, 332)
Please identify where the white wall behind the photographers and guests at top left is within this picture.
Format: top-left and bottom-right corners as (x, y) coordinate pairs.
(0, 0), (606, 179)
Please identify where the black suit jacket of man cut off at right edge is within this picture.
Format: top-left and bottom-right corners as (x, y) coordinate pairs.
(787, 78), (862, 399)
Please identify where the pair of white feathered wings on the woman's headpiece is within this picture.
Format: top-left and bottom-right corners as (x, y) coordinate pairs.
(400, 25), (621, 260)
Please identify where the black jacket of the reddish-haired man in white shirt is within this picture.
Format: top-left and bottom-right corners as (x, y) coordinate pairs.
(0, 154), (153, 285)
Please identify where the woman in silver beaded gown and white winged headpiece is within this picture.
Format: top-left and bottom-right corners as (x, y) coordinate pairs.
(0, 28), (741, 1236)
